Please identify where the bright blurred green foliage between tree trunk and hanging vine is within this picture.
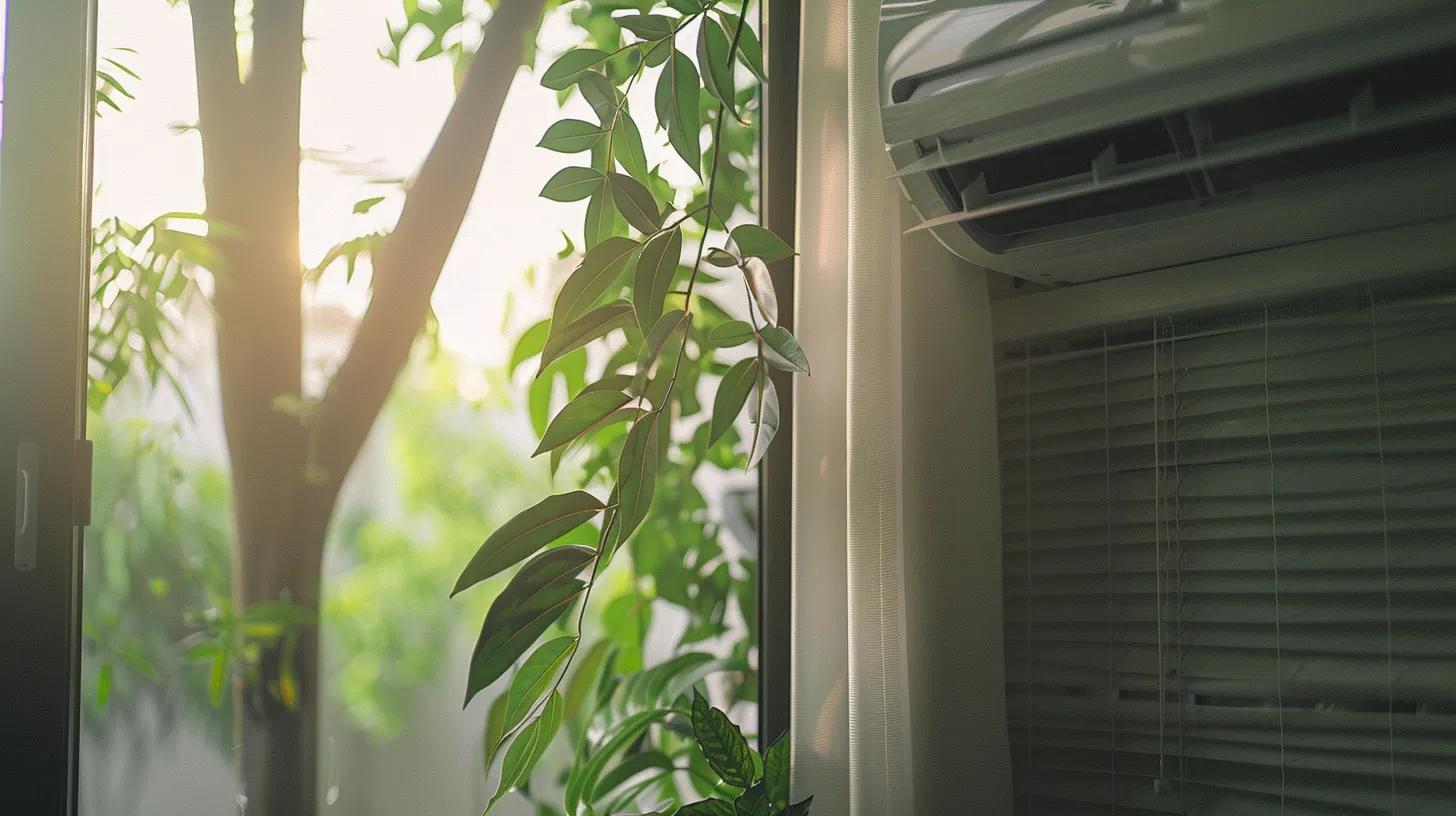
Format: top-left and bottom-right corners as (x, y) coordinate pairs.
(323, 353), (546, 736)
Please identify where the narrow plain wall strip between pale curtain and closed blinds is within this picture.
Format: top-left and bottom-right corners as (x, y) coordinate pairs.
(900, 207), (1012, 816)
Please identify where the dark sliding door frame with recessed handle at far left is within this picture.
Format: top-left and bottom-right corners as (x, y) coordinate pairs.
(0, 0), (93, 815)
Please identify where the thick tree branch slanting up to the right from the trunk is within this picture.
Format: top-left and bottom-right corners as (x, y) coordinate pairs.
(314, 0), (545, 482)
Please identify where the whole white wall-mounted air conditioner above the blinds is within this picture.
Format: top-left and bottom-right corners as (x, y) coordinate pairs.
(879, 0), (1456, 284)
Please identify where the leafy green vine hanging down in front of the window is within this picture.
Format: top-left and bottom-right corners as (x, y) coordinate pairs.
(454, 0), (810, 816)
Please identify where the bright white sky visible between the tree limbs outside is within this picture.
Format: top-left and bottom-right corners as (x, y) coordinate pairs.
(96, 0), (602, 360)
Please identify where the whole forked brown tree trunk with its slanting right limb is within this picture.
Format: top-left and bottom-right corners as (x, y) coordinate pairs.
(189, 0), (545, 816)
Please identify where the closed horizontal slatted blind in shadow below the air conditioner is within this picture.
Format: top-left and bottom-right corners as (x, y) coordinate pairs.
(997, 282), (1456, 816)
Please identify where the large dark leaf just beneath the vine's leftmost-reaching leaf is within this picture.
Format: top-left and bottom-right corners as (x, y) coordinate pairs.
(464, 545), (597, 705)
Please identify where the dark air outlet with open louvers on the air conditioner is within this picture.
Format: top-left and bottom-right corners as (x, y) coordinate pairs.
(920, 48), (1456, 252)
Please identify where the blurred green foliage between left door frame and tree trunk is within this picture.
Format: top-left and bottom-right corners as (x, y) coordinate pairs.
(82, 414), (232, 749)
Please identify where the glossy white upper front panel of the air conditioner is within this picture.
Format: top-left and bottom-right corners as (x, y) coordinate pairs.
(881, 0), (1456, 144)
